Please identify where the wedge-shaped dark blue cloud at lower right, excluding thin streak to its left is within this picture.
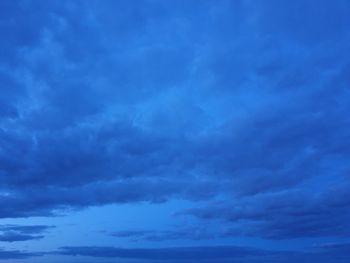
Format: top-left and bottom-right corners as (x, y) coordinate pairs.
(183, 185), (350, 239)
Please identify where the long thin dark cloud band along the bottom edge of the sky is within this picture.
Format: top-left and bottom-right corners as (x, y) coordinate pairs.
(57, 244), (349, 263)
